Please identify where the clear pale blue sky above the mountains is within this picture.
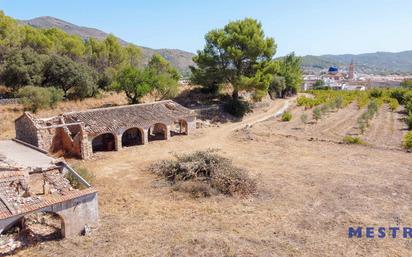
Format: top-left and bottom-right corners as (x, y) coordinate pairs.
(0, 0), (412, 56)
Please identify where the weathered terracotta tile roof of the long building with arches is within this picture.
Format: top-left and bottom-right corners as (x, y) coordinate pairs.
(63, 100), (195, 134)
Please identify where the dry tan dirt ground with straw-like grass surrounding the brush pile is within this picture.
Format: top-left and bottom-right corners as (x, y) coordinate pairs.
(4, 95), (412, 256)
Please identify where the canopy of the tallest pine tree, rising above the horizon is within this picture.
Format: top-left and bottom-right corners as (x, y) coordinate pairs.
(191, 18), (276, 99)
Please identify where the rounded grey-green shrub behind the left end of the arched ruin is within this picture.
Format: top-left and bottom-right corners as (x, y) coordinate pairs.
(17, 86), (63, 112)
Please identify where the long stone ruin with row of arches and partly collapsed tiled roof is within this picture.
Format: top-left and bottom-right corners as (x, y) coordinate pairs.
(15, 100), (196, 159)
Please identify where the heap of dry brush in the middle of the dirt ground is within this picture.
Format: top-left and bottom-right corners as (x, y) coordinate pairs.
(150, 150), (256, 196)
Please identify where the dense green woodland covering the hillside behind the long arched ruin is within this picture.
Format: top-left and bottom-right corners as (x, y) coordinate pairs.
(0, 12), (180, 108)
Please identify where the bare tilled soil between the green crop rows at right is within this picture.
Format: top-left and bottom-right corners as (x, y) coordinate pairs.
(261, 99), (407, 149)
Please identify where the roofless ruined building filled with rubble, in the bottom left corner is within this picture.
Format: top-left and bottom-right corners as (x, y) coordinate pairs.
(0, 155), (98, 238)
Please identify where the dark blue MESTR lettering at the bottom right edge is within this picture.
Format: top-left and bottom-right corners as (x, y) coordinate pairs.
(348, 227), (412, 238)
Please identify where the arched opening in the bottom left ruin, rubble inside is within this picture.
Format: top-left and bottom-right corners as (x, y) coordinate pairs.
(0, 212), (64, 253)
